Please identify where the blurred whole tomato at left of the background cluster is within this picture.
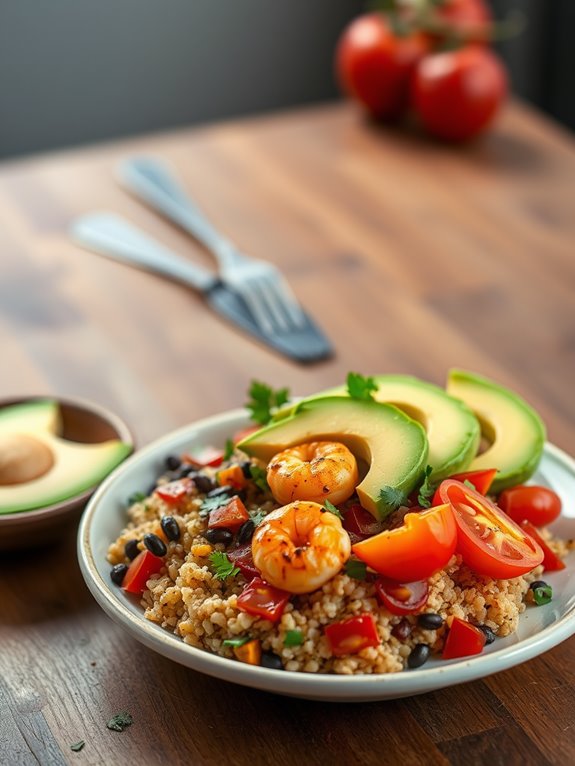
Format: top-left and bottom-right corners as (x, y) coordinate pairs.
(335, 13), (429, 119)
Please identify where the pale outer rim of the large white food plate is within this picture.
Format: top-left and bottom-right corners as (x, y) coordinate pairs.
(77, 408), (575, 701)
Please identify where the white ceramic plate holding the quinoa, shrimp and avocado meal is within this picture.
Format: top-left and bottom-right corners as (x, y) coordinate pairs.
(78, 410), (575, 702)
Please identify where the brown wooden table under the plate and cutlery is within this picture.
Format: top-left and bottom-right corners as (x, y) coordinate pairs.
(0, 105), (575, 766)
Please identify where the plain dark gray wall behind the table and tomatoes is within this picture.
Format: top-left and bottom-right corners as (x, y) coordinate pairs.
(0, 0), (575, 157)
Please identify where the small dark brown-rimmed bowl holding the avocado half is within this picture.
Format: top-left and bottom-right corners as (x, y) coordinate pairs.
(0, 394), (134, 551)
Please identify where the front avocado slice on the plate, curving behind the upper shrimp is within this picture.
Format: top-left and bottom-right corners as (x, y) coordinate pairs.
(237, 396), (427, 518)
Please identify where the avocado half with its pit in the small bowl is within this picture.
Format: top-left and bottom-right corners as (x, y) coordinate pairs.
(0, 399), (132, 514)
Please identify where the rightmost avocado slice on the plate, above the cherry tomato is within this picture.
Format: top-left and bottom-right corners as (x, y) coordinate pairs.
(447, 370), (545, 494)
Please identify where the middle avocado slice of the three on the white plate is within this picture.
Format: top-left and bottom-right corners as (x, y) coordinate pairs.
(280, 375), (481, 482)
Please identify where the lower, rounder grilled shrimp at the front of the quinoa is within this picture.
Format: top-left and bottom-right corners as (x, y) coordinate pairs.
(252, 500), (351, 593)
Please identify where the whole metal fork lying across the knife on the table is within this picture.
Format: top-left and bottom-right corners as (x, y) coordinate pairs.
(118, 157), (306, 334)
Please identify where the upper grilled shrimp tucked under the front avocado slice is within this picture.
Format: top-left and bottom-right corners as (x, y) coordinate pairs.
(267, 442), (358, 504)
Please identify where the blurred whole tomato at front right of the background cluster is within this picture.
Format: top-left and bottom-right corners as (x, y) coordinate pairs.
(411, 45), (507, 141)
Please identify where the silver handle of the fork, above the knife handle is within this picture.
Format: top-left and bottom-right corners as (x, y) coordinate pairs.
(118, 157), (238, 267)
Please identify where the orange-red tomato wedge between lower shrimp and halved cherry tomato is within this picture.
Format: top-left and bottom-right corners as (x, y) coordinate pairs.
(352, 503), (457, 583)
